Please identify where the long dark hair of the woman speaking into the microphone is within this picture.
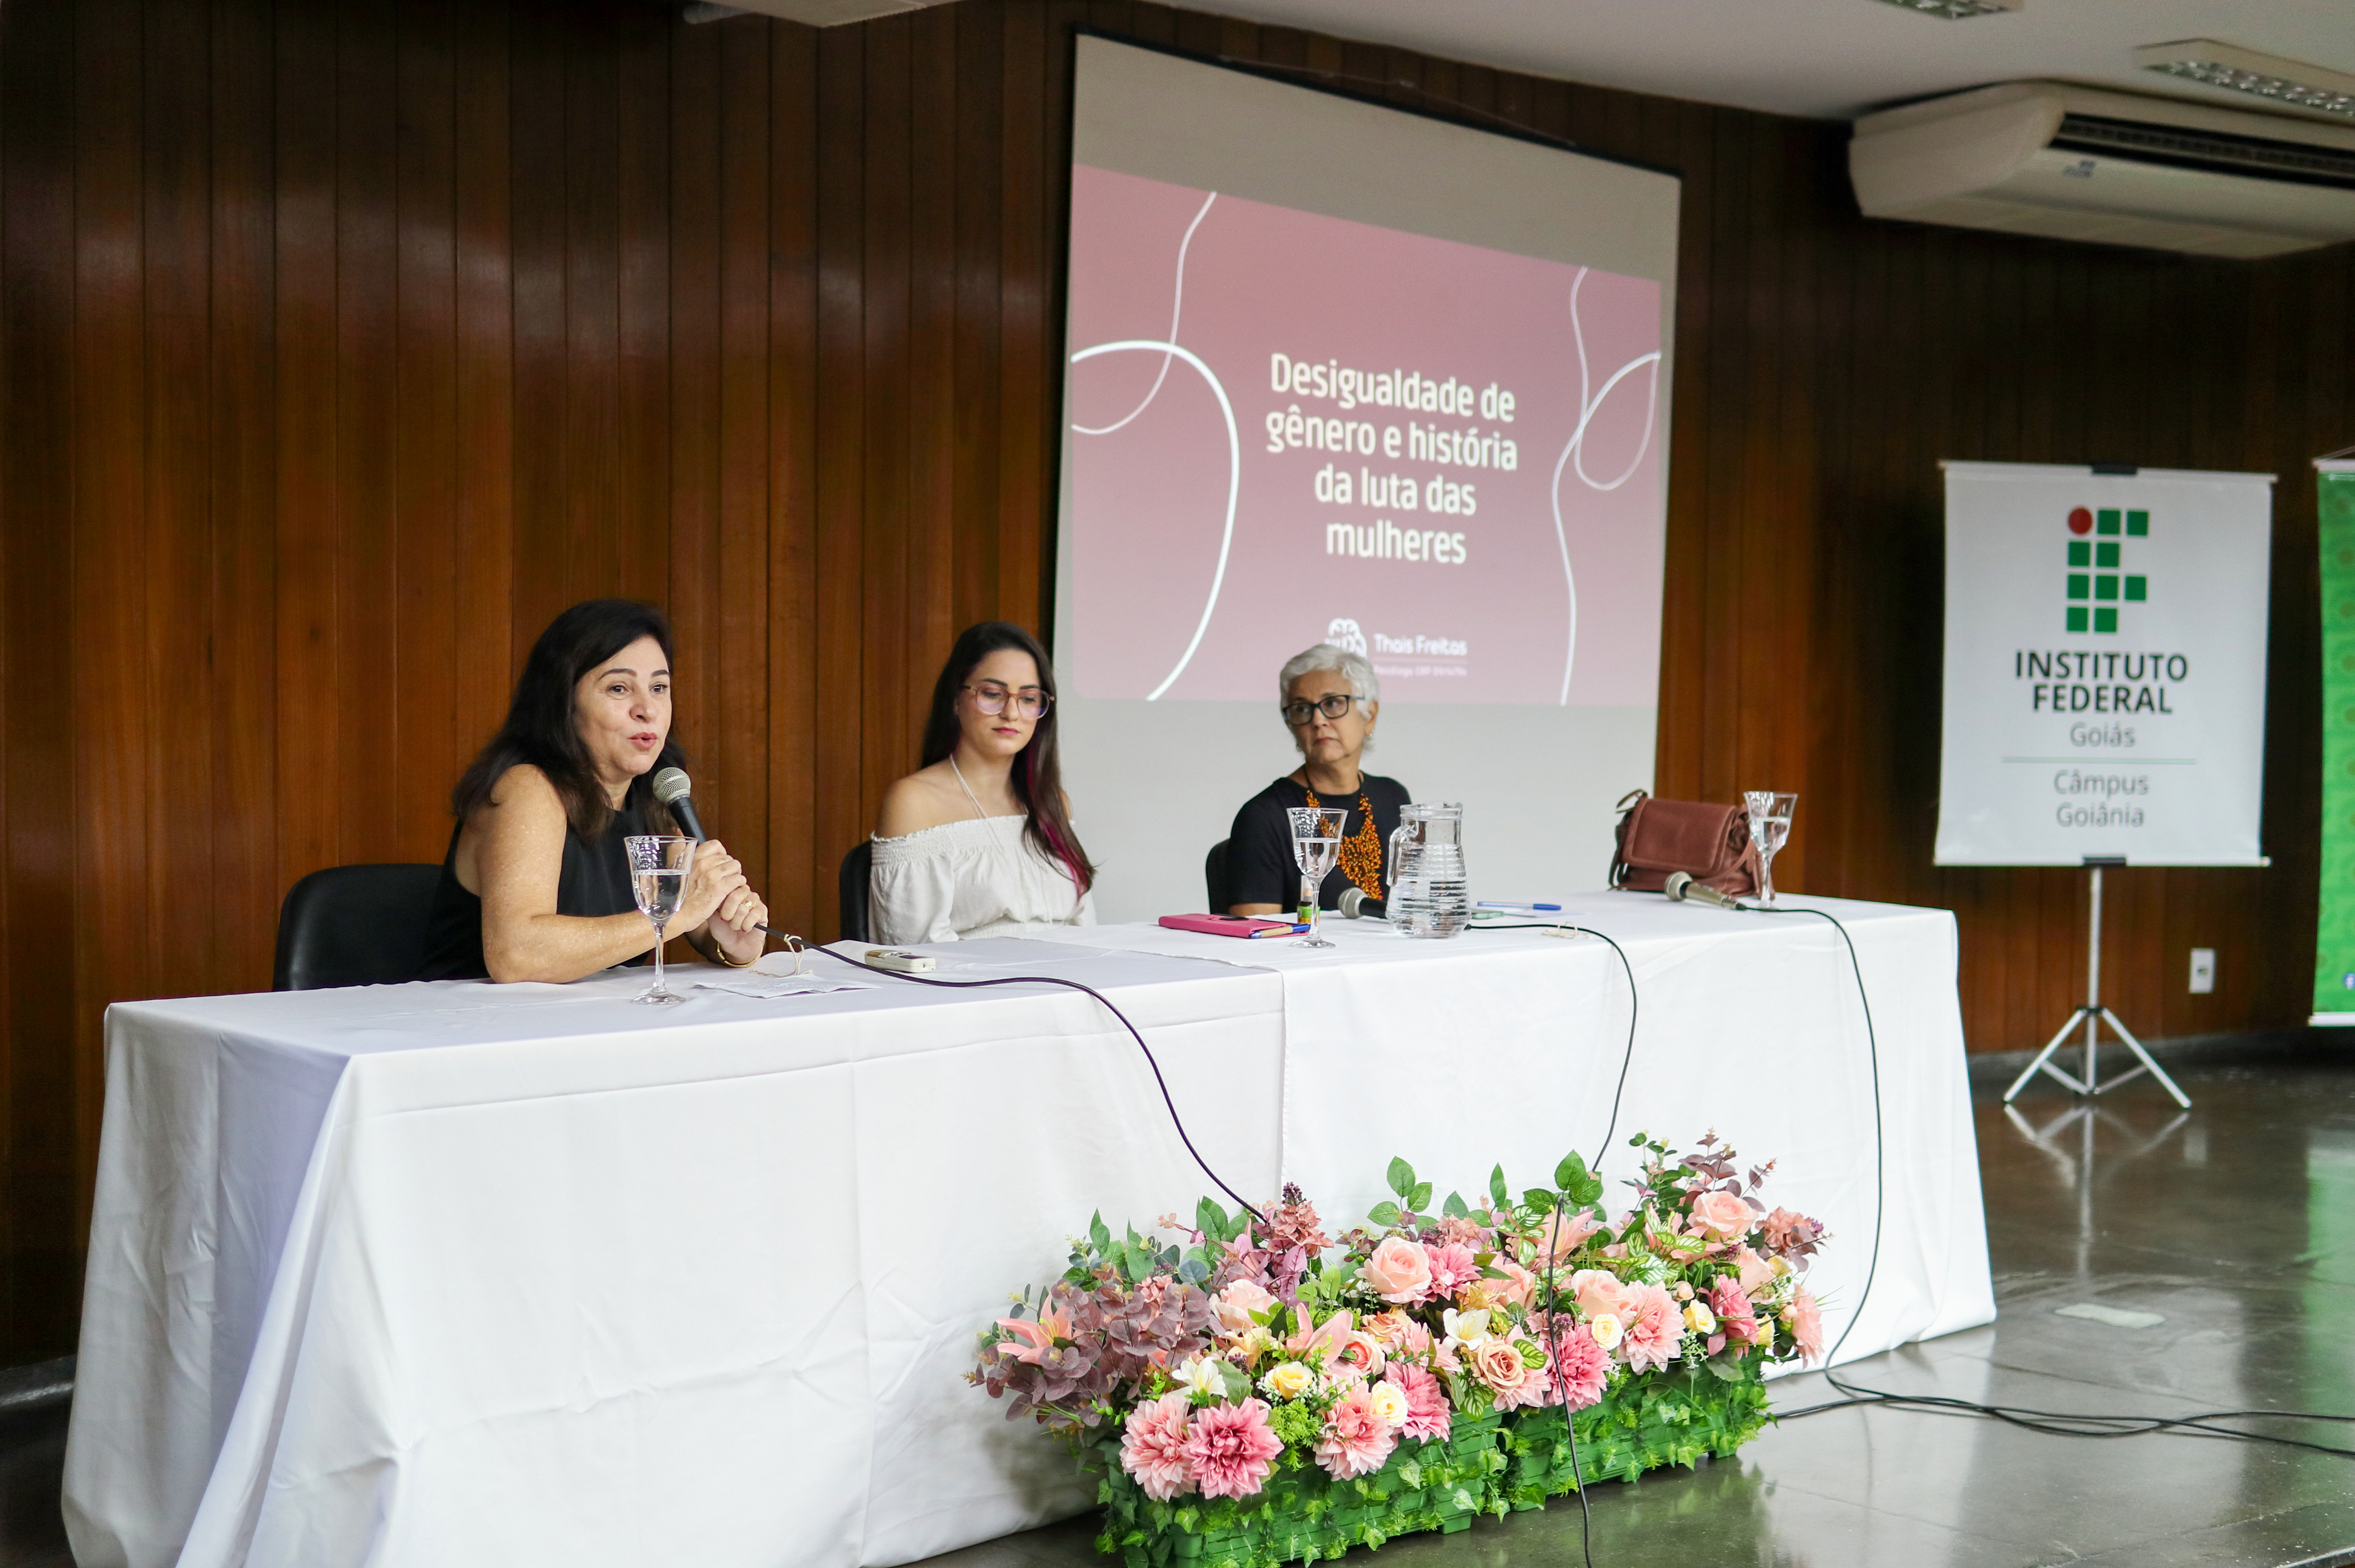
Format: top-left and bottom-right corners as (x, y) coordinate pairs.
(450, 598), (688, 838)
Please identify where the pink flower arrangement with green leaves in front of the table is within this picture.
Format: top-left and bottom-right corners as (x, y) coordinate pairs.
(972, 1132), (1823, 1565)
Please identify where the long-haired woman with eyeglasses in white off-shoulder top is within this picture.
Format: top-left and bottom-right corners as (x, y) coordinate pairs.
(869, 621), (1095, 947)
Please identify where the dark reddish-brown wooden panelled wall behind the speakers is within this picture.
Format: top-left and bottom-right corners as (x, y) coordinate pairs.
(0, 0), (2355, 1358)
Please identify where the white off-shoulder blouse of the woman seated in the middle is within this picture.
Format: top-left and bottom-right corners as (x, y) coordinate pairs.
(866, 817), (1095, 947)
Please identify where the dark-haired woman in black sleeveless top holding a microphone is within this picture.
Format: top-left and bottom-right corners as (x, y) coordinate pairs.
(424, 598), (768, 982)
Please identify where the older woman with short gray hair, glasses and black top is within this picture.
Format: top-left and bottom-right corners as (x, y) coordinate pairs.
(1227, 643), (1408, 916)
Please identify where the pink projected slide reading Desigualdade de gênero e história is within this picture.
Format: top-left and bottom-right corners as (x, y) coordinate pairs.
(1057, 165), (1667, 707)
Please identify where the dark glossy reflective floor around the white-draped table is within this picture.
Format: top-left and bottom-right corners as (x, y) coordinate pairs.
(14, 1048), (2355, 1568)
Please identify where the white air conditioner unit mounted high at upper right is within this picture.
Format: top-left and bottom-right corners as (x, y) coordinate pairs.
(1849, 82), (2355, 257)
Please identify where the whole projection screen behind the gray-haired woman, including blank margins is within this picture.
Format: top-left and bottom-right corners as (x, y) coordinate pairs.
(1053, 38), (1679, 920)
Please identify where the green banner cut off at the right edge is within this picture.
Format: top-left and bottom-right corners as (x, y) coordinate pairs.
(2315, 464), (2355, 1024)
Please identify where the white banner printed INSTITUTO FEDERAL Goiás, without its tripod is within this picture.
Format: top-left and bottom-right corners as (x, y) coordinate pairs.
(1936, 461), (2279, 871)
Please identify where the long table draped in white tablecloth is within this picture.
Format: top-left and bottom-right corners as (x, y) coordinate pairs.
(66, 895), (1995, 1568)
